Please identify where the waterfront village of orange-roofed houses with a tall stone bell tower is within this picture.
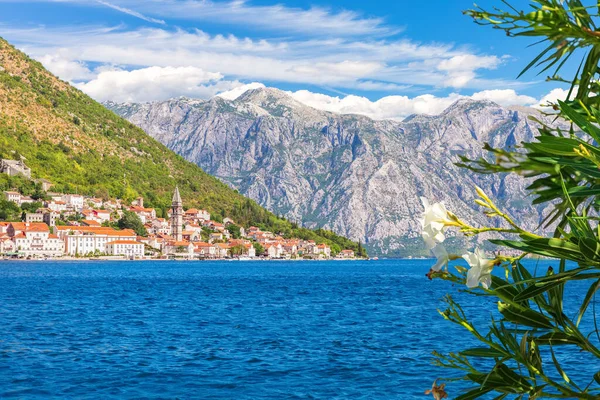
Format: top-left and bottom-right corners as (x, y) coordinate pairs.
(0, 160), (355, 260)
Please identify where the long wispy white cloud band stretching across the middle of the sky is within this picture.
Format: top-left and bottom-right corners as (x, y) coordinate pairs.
(0, 24), (510, 92)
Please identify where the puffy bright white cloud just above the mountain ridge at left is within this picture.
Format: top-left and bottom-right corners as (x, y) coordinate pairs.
(76, 67), (241, 102)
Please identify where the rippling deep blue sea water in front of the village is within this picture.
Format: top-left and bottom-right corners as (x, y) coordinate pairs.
(0, 260), (596, 399)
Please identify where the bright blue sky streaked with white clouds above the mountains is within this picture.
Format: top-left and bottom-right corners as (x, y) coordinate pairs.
(0, 0), (572, 119)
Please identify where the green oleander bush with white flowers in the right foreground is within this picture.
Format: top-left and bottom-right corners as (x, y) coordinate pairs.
(423, 0), (600, 399)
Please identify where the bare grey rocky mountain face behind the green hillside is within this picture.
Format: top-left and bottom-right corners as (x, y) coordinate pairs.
(106, 88), (551, 256)
